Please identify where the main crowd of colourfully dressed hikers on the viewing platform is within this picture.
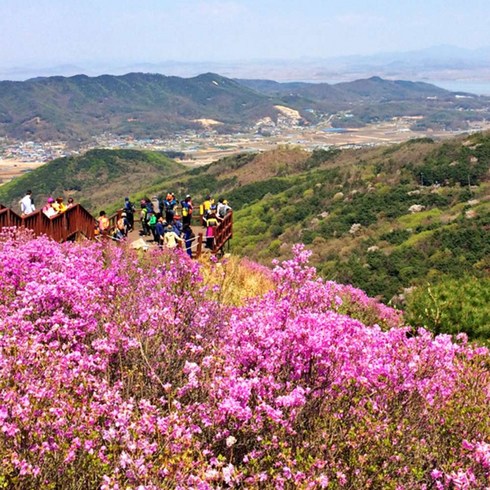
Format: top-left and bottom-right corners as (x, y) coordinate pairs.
(97, 192), (231, 257)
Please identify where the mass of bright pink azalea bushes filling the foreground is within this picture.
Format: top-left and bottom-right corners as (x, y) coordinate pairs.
(0, 230), (490, 490)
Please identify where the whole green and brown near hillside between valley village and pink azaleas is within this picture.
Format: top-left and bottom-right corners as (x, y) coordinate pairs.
(0, 133), (490, 338)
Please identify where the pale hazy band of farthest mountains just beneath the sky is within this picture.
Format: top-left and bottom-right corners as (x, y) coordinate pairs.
(0, 45), (490, 85)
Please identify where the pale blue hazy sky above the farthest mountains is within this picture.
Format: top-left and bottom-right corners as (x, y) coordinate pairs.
(0, 0), (490, 67)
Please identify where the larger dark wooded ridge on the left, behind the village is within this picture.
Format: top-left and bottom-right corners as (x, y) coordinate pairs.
(0, 73), (277, 141)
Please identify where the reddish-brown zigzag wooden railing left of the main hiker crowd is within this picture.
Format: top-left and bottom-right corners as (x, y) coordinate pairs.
(0, 204), (120, 242)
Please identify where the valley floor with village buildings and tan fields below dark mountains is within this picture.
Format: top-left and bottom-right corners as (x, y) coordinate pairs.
(0, 111), (490, 185)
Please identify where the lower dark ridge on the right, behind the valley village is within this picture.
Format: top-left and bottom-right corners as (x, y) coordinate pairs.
(239, 76), (490, 130)
